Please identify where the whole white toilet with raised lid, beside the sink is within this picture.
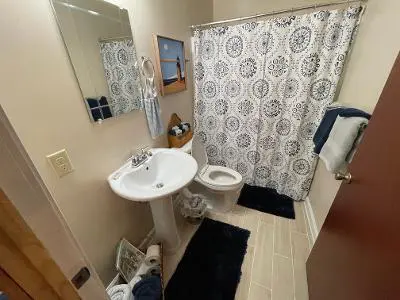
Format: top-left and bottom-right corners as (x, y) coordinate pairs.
(182, 136), (244, 213)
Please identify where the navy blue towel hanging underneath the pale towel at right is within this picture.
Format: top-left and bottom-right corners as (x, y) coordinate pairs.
(313, 106), (371, 154)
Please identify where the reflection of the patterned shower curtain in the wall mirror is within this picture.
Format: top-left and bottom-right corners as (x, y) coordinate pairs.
(100, 39), (141, 116)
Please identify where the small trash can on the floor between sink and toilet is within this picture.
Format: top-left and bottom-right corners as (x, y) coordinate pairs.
(179, 189), (207, 224)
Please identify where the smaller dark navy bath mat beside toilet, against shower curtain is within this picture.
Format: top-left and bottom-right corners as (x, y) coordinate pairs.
(238, 184), (295, 219)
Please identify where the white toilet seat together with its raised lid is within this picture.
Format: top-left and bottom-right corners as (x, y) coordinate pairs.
(192, 136), (243, 191)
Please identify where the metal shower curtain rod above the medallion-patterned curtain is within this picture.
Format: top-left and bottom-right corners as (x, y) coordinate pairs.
(190, 0), (368, 29)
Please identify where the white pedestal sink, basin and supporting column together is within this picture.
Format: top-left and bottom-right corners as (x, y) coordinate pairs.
(107, 148), (197, 253)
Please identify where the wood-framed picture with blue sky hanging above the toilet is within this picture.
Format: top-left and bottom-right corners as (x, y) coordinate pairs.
(153, 35), (186, 96)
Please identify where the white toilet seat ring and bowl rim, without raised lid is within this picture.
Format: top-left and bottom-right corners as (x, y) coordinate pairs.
(195, 165), (243, 191)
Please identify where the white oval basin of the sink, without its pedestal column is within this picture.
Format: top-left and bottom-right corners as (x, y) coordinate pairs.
(108, 148), (197, 201)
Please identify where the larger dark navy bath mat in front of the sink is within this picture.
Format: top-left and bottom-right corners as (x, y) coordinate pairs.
(165, 218), (250, 300)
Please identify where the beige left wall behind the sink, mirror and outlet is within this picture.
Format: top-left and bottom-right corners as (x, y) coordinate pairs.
(0, 0), (212, 282)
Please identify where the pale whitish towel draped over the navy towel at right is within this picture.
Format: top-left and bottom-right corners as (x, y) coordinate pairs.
(319, 116), (368, 173)
